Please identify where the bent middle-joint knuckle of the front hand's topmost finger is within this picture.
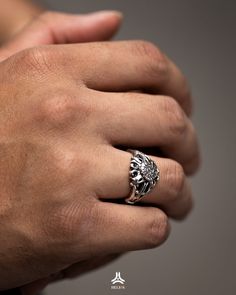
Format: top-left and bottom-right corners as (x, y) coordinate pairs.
(136, 41), (168, 82)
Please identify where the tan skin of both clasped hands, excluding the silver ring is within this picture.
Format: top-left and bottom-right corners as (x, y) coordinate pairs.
(0, 9), (199, 294)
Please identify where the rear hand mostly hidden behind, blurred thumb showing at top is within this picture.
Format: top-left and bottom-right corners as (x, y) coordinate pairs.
(0, 8), (122, 294)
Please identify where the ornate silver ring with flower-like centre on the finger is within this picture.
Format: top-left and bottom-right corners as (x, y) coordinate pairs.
(125, 150), (160, 205)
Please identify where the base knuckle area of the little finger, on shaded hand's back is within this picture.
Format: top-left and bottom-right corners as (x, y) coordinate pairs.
(40, 198), (97, 264)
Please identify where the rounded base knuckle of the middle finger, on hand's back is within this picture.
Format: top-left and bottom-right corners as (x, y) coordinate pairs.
(34, 87), (93, 131)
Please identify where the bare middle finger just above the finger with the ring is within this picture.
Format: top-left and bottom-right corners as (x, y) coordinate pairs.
(96, 92), (200, 174)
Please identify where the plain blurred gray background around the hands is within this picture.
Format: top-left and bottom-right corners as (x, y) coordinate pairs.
(37, 0), (236, 295)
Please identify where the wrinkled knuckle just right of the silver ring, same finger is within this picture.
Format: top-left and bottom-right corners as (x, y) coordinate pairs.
(166, 161), (185, 201)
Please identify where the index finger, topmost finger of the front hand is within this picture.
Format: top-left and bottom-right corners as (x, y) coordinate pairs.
(60, 41), (192, 115)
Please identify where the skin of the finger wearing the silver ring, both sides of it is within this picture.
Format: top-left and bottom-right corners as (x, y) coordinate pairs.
(93, 146), (192, 219)
